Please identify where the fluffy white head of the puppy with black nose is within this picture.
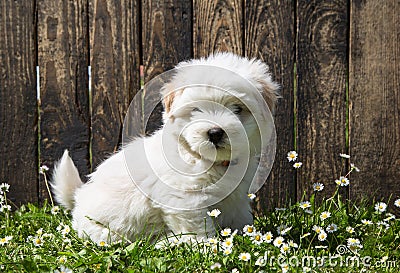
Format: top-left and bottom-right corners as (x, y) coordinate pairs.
(162, 53), (278, 163)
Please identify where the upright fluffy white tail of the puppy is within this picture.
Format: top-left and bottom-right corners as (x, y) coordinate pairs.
(51, 150), (83, 209)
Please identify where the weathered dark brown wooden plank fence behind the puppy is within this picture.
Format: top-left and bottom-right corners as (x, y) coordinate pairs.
(0, 0), (400, 206)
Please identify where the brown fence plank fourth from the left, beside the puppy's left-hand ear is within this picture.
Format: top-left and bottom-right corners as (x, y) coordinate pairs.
(142, 0), (192, 134)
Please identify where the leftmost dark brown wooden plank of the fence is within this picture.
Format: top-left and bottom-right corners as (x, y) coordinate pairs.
(0, 1), (38, 203)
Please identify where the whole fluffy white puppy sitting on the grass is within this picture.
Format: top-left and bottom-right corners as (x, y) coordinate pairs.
(52, 53), (278, 242)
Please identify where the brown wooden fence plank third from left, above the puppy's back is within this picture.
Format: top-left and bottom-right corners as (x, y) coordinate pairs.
(89, 0), (140, 167)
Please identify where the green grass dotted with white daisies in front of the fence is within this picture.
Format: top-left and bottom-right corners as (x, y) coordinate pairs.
(0, 154), (400, 273)
